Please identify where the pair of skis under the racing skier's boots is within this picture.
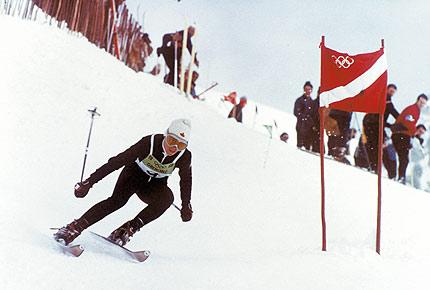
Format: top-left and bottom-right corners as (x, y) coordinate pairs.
(53, 231), (151, 262)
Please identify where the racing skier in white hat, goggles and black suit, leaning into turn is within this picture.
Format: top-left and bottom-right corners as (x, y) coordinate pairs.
(54, 119), (193, 246)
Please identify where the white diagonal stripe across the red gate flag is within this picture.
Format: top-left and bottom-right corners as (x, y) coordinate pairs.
(320, 53), (387, 107)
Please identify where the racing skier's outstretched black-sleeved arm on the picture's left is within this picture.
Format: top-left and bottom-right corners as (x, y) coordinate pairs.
(88, 136), (150, 185)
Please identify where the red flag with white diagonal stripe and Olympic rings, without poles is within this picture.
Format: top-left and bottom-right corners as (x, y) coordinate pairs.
(320, 43), (387, 113)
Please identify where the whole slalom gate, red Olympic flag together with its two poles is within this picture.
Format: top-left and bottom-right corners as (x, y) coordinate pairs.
(320, 36), (387, 254)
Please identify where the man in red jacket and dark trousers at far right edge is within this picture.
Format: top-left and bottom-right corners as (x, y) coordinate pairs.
(391, 94), (428, 184)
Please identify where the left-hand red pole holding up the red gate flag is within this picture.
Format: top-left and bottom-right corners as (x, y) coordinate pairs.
(319, 36), (327, 251)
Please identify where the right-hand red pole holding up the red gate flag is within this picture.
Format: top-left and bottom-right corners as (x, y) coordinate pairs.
(376, 39), (386, 255)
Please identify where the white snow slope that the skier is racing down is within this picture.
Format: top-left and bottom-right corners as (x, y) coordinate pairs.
(0, 16), (430, 289)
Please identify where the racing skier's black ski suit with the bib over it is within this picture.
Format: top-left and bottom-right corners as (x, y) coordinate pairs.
(81, 134), (192, 229)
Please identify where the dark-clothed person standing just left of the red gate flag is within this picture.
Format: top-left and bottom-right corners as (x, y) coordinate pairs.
(294, 81), (314, 150)
